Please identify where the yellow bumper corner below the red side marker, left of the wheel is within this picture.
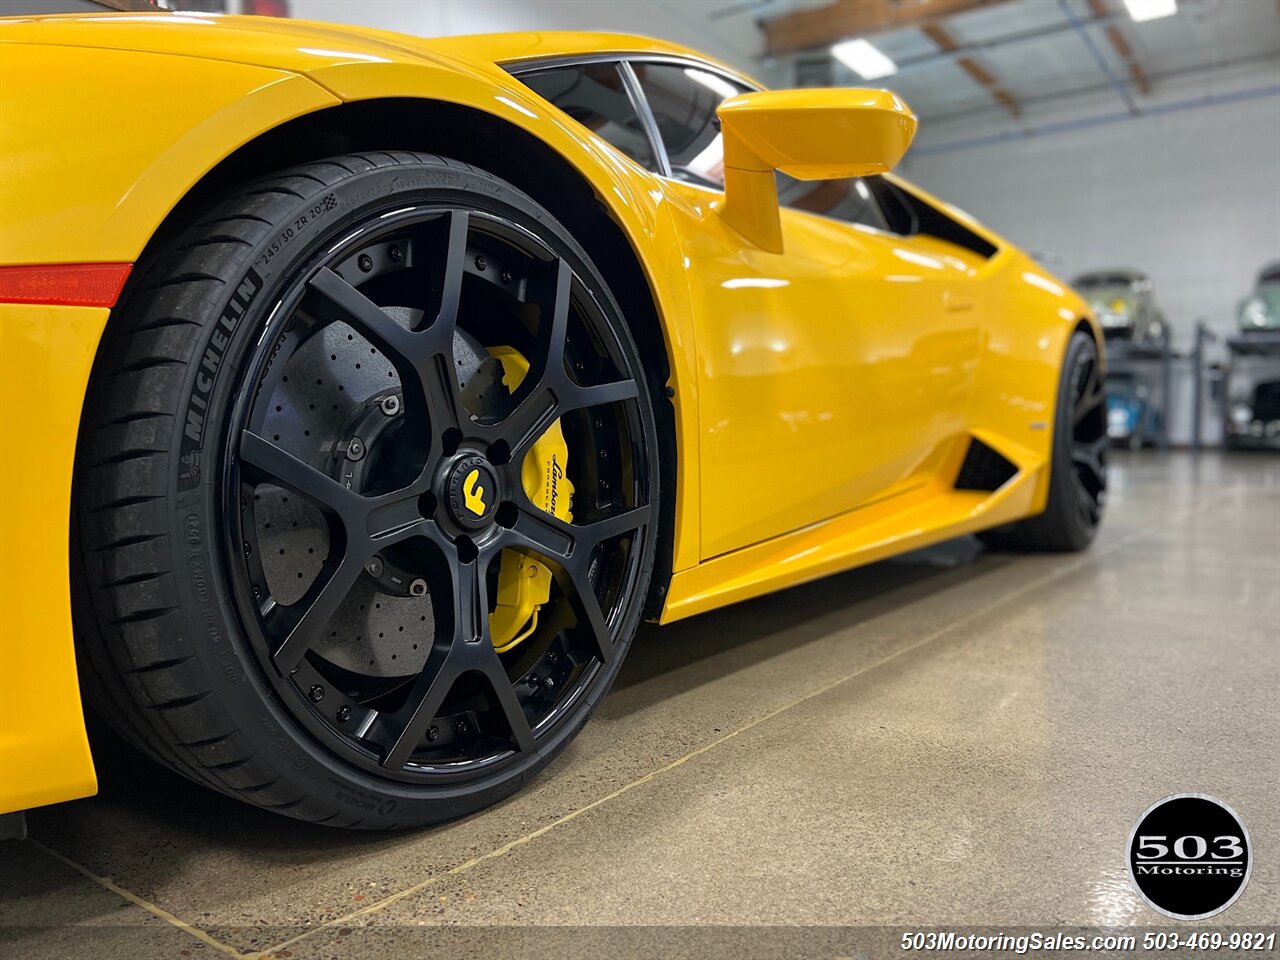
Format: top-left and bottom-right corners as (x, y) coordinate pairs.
(0, 303), (108, 813)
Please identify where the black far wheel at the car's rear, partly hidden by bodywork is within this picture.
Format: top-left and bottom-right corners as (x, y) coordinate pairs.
(978, 330), (1110, 552)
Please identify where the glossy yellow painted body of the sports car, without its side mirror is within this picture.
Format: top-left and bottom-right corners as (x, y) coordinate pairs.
(0, 13), (1092, 812)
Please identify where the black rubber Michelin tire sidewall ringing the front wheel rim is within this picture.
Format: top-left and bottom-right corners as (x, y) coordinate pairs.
(156, 161), (660, 827)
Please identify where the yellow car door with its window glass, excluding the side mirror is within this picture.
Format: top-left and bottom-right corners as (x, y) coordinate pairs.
(628, 60), (979, 558)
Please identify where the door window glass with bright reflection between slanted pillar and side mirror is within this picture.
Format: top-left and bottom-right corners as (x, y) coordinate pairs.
(631, 63), (745, 188)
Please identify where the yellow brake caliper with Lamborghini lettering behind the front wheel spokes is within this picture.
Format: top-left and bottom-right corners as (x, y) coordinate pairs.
(489, 347), (573, 653)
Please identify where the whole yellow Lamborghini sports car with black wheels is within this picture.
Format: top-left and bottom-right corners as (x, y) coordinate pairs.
(0, 13), (1107, 828)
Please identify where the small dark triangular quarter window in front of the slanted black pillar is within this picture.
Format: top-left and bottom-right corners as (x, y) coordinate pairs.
(520, 63), (655, 170)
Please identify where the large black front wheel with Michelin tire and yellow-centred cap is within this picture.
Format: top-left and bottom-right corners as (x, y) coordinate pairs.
(77, 154), (659, 828)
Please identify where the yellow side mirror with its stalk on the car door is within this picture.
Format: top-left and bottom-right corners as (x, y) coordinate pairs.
(717, 88), (915, 253)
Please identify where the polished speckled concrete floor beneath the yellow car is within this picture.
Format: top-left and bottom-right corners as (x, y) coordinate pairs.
(0, 454), (1280, 960)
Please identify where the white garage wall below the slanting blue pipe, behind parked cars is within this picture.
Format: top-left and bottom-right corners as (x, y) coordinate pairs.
(905, 88), (1280, 348)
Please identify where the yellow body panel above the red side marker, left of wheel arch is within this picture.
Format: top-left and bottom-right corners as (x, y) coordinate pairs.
(0, 44), (338, 264)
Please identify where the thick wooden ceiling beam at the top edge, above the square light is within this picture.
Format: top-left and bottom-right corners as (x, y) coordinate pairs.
(762, 0), (1009, 56)
